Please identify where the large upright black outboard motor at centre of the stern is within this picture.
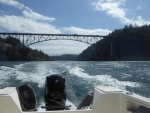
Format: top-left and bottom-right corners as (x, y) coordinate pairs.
(45, 75), (68, 110)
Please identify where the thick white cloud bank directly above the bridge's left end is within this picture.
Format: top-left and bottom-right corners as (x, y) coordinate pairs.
(0, 15), (61, 33)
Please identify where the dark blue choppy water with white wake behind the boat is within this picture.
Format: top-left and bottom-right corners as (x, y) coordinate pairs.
(0, 61), (150, 109)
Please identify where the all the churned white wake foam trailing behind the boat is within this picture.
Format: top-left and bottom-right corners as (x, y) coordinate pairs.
(0, 62), (140, 89)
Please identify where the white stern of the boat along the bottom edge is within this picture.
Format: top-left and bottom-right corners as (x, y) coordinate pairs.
(0, 86), (150, 113)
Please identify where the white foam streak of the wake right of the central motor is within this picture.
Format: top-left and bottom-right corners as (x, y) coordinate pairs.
(69, 67), (140, 89)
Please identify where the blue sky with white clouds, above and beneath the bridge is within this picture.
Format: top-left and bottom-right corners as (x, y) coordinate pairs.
(0, 0), (150, 55)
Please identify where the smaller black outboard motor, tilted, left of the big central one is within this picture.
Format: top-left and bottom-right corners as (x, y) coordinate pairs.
(18, 85), (36, 111)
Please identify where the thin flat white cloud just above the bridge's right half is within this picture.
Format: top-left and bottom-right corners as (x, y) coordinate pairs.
(62, 27), (111, 35)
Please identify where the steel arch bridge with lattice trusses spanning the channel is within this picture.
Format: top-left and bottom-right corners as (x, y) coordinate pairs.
(0, 33), (106, 46)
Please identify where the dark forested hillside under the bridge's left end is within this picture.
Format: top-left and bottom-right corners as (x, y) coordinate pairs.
(0, 37), (52, 61)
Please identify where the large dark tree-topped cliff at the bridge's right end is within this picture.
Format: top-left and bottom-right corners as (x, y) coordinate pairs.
(77, 25), (150, 61)
